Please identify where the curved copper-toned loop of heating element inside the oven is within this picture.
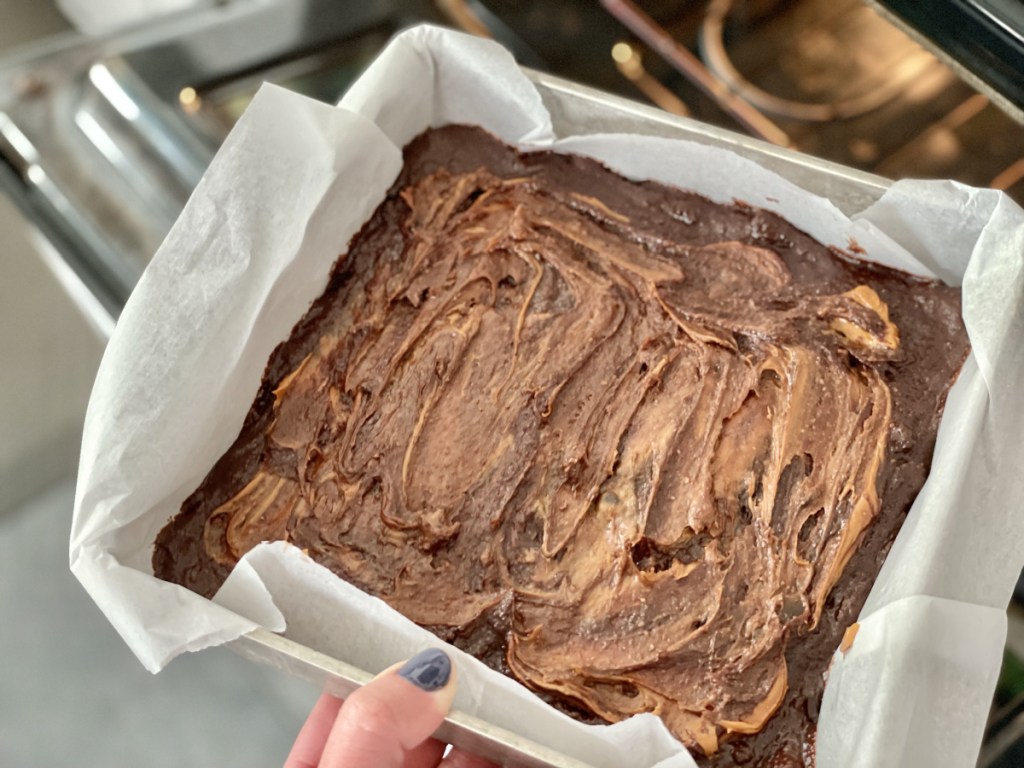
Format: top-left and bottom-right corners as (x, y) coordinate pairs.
(700, 0), (932, 122)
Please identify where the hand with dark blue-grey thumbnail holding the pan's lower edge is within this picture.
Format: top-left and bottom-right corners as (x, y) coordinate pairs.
(285, 649), (497, 768)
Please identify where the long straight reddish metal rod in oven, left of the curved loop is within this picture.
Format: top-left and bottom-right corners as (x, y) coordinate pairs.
(601, 0), (791, 146)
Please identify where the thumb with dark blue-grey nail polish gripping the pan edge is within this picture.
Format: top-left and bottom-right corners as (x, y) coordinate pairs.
(321, 648), (456, 768)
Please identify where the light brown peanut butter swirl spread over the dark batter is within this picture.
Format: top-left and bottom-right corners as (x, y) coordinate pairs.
(204, 170), (899, 754)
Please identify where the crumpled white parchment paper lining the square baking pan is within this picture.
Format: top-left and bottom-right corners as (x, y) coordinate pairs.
(70, 27), (1024, 768)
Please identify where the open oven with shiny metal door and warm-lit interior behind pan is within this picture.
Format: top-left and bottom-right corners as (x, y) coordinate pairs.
(0, 0), (1024, 768)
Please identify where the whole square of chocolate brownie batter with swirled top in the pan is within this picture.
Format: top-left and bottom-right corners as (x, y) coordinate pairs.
(154, 126), (968, 766)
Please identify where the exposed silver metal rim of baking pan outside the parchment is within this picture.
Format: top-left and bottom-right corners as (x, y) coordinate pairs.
(227, 70), (891, 768)
